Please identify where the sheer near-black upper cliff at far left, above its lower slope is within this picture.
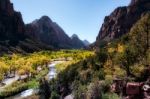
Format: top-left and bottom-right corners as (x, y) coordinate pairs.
(0, 0), (25, 40)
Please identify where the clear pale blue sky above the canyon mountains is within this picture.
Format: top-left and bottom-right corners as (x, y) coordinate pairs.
(11, 0), (130, 42)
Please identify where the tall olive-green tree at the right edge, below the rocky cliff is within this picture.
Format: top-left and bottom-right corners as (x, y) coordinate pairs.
(129, 12), (150, 62)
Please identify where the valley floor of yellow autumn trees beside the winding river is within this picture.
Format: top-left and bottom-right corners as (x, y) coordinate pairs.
(0, 50), (93, 97)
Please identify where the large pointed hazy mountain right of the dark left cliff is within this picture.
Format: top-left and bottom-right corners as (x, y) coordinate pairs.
(26, 16), (72, 49)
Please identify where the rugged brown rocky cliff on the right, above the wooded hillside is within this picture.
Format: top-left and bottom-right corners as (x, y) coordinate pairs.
(96, 0), (150, 45)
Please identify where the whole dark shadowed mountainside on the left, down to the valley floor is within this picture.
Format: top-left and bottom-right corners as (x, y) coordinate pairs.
(0, 0), (52, 54)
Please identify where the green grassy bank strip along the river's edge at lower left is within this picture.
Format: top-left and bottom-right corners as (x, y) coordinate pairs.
(0, 68), (48, 99)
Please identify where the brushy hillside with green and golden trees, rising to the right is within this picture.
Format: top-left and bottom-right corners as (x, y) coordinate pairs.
(48, 13), (150, 99)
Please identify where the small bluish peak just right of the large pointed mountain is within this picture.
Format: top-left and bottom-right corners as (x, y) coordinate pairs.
(71, 34), (85, 49)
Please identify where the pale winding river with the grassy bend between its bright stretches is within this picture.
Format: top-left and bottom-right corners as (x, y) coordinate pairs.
(2, 61), (65, 99)
